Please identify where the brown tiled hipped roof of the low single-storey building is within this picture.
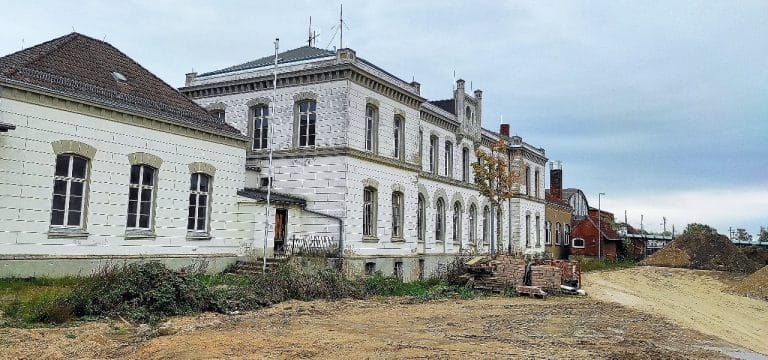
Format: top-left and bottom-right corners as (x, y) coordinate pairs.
(0, 33), (240, 135)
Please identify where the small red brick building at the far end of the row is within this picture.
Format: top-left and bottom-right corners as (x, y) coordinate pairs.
(571, 207), (624, 260)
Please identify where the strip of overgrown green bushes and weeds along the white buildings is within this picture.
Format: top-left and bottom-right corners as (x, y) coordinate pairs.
(0, 261), (475, 325)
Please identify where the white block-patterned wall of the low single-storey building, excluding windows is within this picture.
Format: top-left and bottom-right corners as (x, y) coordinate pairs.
(0, 98), (251, 255)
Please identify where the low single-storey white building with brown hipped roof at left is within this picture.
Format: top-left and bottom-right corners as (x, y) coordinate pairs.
(0, 33), (248, 277)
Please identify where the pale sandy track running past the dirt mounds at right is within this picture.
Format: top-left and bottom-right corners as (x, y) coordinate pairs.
(583, 267), (768, 355)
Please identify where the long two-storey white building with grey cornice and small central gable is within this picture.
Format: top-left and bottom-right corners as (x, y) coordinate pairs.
(180, 46), (547, 278)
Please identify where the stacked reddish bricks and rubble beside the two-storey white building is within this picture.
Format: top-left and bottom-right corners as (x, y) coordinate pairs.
(467, 255), (581, 293)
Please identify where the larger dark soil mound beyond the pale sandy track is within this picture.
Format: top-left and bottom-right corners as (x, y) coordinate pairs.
(646, 232), (759, 273)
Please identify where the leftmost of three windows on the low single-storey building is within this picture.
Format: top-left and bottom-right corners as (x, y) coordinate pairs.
(51, 154), (88, 228)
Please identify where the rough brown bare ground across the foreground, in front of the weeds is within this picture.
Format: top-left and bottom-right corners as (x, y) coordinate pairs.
(0, 297), (727, 360)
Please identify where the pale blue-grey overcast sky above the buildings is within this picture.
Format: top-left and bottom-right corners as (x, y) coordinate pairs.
(0, 0), (768, 233)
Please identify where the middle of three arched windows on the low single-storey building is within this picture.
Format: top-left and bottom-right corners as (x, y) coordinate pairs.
(125, 165), (155, 229)
